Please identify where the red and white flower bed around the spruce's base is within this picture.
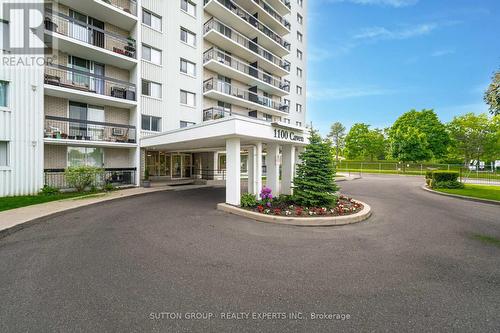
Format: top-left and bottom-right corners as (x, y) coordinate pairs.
(242, 188), (363, 218)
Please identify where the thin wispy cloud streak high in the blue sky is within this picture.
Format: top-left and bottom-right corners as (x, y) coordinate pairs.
(354, 23), (437, 40)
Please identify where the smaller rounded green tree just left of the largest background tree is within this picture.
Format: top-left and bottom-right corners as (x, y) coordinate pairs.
(345, 123), (386, 161)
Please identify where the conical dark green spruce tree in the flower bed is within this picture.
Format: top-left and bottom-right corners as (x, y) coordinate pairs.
(293, 130), (338, 208)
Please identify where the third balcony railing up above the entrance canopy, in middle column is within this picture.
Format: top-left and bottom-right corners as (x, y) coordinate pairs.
(203, 48), (290, 92)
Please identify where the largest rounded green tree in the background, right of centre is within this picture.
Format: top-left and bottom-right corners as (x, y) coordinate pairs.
(389, 109), (450, 161)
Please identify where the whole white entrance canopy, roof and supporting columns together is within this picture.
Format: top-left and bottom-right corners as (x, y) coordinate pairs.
(141, 115), (309, 205)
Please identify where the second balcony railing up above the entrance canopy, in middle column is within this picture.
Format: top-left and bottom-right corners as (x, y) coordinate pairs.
(203, 78), (289, 113)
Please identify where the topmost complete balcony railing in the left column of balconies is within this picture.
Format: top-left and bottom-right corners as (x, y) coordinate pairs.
(44, 9), (136, 59)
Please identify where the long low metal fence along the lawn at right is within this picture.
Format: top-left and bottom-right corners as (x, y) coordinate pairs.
(336, 160), (500, 185)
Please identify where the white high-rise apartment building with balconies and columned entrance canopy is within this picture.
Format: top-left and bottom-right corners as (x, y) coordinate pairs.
(0, 0), (307, 203)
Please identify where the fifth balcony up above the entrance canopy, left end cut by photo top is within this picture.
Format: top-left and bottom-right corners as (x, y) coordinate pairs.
(205, 0), (290, 57)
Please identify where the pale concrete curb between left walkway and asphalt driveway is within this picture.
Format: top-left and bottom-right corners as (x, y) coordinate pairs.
(0, 188), (172, 239)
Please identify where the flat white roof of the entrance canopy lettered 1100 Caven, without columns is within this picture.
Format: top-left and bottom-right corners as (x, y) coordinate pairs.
(141, 115), (309, 151)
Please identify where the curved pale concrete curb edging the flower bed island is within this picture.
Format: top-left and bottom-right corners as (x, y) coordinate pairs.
(217, 201), (372, 227)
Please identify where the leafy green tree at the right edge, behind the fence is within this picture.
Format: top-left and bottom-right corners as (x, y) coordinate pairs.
(448, 113), (500, 164)
